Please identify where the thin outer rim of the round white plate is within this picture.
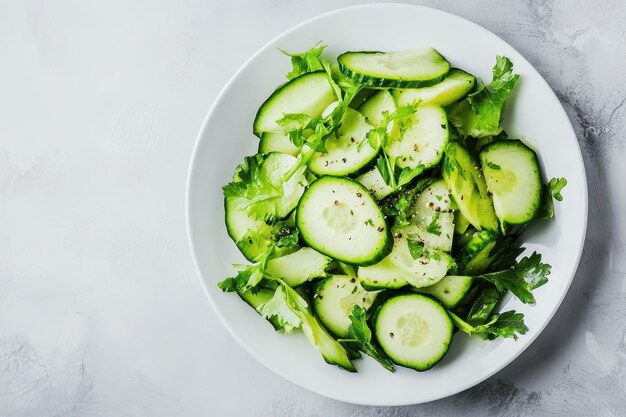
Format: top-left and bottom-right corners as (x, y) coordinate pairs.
(184, 2), (589, 406)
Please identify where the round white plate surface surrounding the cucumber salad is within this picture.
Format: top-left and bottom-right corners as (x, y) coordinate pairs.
(187, 4), (587, 405)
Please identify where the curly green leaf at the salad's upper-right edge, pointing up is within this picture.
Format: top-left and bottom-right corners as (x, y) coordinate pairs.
(448, 55), (519, 138)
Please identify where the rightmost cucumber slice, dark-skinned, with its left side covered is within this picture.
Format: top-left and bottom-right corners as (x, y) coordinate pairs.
(480, 140), (542, 234)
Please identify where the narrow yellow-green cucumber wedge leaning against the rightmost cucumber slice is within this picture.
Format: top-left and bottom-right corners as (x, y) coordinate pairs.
(441, 142), (498, 230)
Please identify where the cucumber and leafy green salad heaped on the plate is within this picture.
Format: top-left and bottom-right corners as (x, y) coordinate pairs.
(218, 44), (567, 372)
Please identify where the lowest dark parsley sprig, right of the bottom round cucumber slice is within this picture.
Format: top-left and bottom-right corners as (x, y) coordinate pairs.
(449, 310), (528, 340)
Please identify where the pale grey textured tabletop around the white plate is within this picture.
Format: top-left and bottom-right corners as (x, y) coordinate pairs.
(0, 0), (626, 417)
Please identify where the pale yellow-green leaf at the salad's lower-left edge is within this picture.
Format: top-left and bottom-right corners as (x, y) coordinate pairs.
(257, 280), (308, 334)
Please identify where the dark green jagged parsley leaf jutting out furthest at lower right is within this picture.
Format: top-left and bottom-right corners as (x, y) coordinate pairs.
(479, 252), (552, 304)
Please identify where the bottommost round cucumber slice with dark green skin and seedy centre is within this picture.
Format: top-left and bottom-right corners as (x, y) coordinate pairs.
(373, 294), (454, 371)
